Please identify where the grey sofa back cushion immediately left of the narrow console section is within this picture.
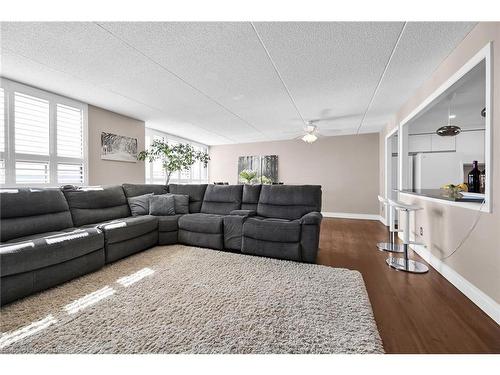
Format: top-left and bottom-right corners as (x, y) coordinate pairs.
(201, 185), (243, 215)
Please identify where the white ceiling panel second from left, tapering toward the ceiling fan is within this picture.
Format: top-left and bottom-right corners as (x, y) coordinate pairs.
(96, 22), (303, 132)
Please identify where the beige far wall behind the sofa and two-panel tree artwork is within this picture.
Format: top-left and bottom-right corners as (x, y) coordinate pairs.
(209, 134), (379, 215)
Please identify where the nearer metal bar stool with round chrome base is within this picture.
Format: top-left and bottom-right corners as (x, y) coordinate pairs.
(385, 199), (429, 273)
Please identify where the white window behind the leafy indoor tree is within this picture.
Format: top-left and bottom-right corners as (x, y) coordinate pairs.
(145, 126), (209, 184)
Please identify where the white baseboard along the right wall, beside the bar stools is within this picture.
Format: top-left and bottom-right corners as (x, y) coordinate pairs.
(410, 245), (500, 324)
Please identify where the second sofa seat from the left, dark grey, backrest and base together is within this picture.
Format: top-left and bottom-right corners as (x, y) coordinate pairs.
(64, 186), (158, 263)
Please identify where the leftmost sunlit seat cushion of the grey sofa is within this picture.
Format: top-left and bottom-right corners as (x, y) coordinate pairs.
(0, 228), (104, 277)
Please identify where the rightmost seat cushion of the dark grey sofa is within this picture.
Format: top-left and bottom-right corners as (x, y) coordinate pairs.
(243, 217), (300, 242)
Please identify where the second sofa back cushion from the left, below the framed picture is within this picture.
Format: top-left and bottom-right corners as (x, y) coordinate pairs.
(64, 185), (130, 227)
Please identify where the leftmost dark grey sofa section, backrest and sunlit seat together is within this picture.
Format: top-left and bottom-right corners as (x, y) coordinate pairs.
(0, 188), (105, 305)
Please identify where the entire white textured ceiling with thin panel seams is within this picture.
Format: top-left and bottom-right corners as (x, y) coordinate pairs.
(0, 22), (474, 145)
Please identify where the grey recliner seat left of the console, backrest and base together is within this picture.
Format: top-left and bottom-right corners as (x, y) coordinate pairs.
(179, 185), (243, 250)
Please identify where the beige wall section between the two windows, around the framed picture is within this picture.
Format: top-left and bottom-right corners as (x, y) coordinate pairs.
(88, 105), (145, 185)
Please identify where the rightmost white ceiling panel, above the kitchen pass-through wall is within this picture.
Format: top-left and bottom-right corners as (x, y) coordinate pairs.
(365, 22), (476, 131)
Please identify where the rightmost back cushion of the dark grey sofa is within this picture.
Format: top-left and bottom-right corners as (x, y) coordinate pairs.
(257, 185), (321, 220)
